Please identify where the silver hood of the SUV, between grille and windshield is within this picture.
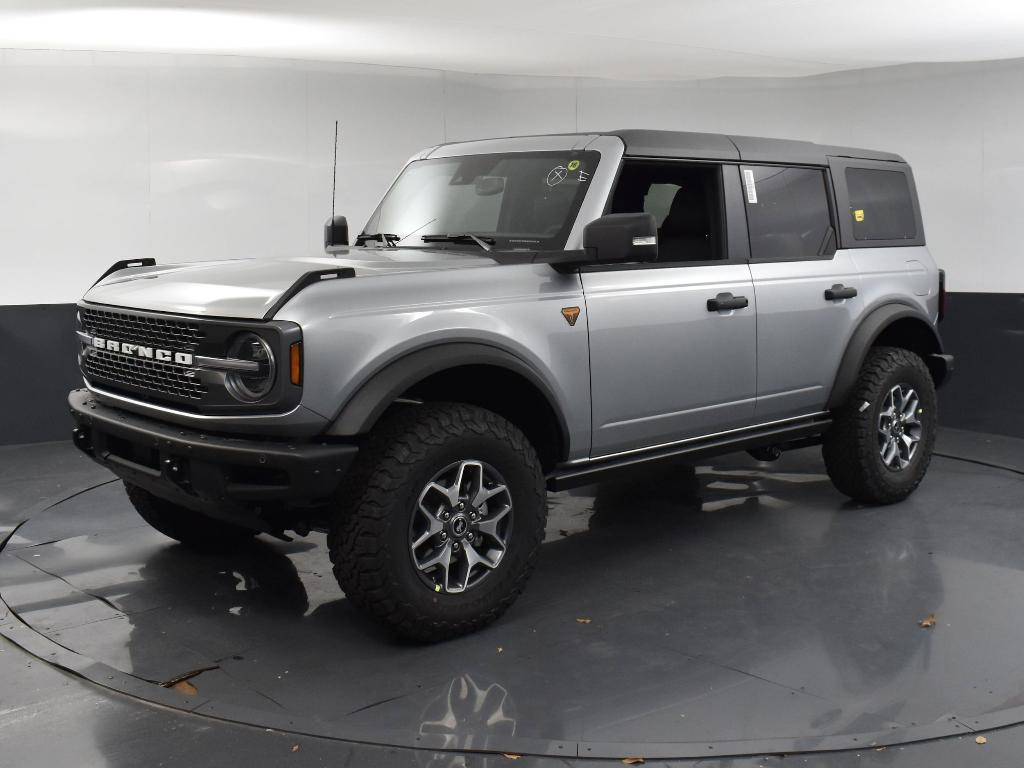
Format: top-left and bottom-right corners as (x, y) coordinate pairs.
(84, 248), (498, 319)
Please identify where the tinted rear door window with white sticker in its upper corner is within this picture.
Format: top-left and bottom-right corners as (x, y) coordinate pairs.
(742, 166), (836, 260)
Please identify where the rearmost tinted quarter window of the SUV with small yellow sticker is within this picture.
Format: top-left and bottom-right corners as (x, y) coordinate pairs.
(846, 168), (918, 241)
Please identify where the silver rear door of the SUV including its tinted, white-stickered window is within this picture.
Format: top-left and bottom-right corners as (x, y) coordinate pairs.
(741, 165), (862, 423)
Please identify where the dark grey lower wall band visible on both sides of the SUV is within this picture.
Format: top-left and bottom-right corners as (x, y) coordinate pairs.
(0, 293), (1024, 444)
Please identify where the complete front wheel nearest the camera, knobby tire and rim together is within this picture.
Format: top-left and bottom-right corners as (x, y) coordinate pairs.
(328, 403), (547, 641)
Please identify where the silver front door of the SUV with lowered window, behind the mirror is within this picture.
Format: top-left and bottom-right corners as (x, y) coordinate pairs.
(581, 160), (757, 457)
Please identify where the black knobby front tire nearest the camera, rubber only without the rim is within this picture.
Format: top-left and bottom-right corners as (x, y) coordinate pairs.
(328, 403), (547, 642)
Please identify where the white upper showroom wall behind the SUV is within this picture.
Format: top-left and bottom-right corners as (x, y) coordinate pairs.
(0, 50), (1024, 305)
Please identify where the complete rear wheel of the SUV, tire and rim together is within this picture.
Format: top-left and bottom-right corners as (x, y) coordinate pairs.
(822, 347), (938, 504)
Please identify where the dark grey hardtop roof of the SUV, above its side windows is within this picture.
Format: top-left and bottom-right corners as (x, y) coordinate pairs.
(604, 128), (905, 166)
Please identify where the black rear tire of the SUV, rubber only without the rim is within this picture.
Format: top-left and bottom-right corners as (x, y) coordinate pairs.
(821, 347), (938, 504)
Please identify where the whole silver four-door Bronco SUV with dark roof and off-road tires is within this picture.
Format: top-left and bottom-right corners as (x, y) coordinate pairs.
(70, 130), (952, 640)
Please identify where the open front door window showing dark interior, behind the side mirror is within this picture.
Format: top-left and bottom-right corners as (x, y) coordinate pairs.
(610, 160), (725, 262)
